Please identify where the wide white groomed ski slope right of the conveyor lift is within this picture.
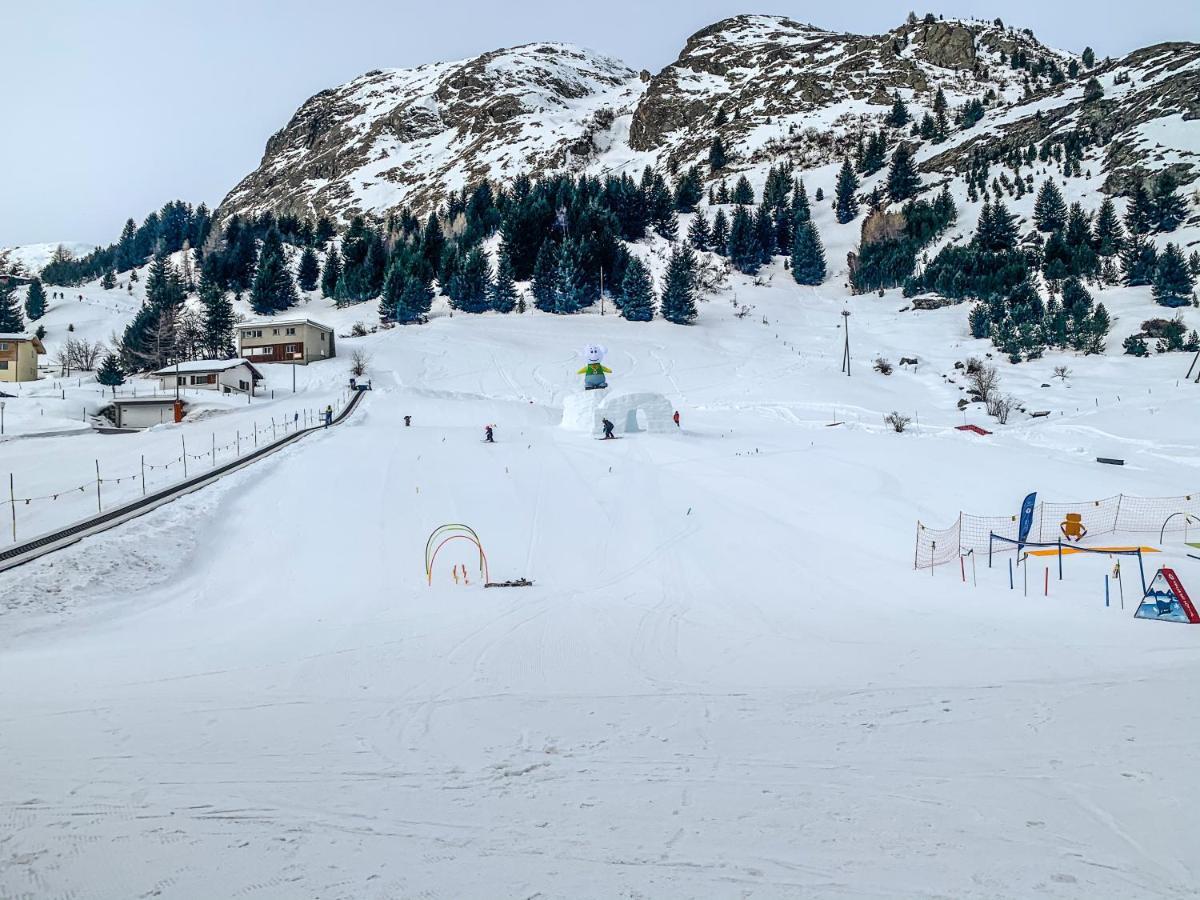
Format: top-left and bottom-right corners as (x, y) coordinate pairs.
(0, 277), (1200, 900)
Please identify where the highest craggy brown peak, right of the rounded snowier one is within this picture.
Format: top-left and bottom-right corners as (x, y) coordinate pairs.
(629, 16), (1069, 168)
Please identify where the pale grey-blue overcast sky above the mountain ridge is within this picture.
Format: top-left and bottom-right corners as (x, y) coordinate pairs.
(0, 0), (1200, 247)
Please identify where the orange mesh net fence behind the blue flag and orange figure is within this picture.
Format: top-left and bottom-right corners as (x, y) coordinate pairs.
(913, 493), (1200, 569)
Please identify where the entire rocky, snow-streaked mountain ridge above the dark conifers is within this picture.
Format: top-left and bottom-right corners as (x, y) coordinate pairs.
(218, 16), (1200, 229)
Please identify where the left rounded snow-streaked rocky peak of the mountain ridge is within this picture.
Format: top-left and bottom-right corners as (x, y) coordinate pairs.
(220, 43), (642, 229)
